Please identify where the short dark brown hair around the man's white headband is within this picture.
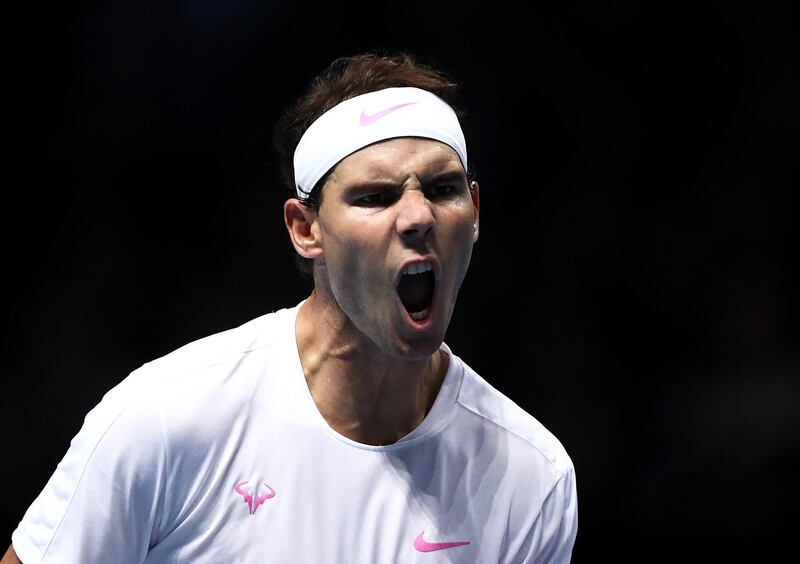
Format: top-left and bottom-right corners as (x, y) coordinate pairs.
(272, 53), (476, 276)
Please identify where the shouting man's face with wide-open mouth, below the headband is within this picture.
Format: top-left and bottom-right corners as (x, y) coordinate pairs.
(312, 137), (478, 360)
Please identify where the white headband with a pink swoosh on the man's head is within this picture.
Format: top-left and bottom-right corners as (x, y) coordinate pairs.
(294, 87), (467, 198)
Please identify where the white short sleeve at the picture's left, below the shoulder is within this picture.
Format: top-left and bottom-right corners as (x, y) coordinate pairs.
(12, 374), (167, 564)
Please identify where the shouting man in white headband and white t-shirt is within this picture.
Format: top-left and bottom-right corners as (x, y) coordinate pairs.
(3, 55), (577, 564)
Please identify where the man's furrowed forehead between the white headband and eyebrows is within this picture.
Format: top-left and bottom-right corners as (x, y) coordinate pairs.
(329, 137), (464, 184)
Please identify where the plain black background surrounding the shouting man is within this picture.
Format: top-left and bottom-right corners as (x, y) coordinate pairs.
(0, 0), (800, 562)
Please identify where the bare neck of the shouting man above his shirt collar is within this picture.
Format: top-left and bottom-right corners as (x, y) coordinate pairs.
(295, 291), (448, 445)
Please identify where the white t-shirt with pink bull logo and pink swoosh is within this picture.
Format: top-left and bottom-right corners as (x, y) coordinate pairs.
(12, 305), (577, 564)
